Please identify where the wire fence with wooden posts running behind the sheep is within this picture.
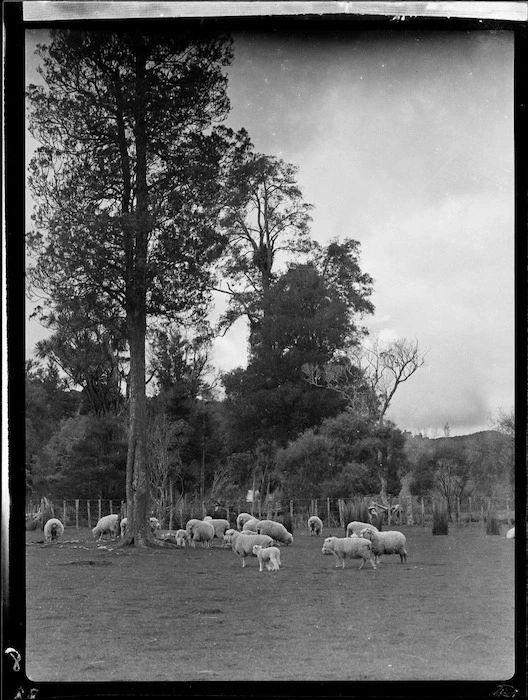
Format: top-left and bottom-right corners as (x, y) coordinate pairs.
(26, 494), (515, 530)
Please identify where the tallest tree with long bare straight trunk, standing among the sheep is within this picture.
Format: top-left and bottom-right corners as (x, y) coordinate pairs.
(27, 29), (237, 545)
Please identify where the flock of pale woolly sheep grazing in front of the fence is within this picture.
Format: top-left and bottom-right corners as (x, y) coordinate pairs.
(44, 513), (515, 571)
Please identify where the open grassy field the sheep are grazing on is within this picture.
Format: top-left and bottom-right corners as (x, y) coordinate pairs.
(26, 527), (514, 682)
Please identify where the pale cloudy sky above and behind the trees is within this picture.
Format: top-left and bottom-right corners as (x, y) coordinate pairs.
(26, 30), (514, 437)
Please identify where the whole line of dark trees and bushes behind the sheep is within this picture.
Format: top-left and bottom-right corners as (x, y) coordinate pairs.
(26, 27), (506, 545)
